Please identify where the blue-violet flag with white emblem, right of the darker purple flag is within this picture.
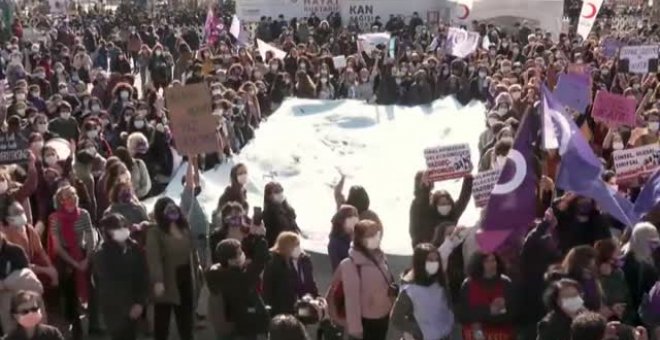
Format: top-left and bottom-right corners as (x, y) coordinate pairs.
(542, 86), (632, 226)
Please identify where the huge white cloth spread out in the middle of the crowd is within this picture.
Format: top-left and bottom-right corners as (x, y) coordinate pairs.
(145, 98), (485, 254)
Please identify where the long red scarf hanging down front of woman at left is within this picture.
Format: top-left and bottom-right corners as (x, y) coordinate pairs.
(55, 208), (89, 303)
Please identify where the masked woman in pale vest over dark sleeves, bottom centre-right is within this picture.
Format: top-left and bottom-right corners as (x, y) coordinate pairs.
(390, 243), (454, 339)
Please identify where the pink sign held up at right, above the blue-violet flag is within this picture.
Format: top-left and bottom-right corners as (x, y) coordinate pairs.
(591, 90), (637, 126)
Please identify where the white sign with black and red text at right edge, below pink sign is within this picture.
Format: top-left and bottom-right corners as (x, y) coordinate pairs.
(612, 144), (660, 182)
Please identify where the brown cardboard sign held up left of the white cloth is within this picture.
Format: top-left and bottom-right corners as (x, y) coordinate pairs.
(165, 83), (218, 155)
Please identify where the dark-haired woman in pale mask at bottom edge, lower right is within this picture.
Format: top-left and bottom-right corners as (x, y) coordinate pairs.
(537, 279), (586, 340)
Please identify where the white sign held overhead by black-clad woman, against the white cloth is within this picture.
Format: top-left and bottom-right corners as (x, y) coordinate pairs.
(424, 144), (473, 182)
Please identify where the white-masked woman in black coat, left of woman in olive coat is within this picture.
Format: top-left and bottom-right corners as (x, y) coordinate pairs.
(92, 214), (149, 340)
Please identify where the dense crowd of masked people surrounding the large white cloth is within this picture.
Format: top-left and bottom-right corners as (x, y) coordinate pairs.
(0, 1), (660, 340)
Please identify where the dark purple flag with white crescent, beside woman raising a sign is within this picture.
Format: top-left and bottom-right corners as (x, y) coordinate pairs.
(477, 114), (538, 252)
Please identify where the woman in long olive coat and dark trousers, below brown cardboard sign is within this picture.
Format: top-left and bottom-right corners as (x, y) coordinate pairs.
(146, 197), (197, 340)
